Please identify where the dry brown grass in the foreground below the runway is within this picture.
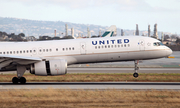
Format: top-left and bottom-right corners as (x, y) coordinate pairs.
(0, 89), (180, 108)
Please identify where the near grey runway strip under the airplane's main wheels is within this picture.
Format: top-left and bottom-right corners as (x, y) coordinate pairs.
(0, 82), (180, 90)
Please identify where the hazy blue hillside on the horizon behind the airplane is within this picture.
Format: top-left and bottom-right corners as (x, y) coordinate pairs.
(0, 17), (172, 38)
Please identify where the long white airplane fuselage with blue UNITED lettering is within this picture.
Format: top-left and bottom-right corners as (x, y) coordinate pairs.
(0, 36), (172, 65)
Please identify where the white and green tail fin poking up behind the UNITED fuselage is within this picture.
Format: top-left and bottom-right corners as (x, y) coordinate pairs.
(102, 25), (116, 37)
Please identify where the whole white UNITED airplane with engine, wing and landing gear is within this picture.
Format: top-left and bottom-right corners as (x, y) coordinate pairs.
(0, 36), (172, 84)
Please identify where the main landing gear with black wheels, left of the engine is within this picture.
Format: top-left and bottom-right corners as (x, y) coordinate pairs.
(12, 65), (26, 84)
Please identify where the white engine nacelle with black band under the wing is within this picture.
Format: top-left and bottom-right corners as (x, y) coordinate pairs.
(30, 59), (67, 76)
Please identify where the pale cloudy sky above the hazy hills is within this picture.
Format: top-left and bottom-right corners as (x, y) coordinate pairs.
(0, 0), (180, 34)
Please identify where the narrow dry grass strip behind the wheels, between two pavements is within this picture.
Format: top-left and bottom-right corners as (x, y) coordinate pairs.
(0, 73), (180, 82)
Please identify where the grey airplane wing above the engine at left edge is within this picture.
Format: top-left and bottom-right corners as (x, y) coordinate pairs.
(0, 55), (42, 70)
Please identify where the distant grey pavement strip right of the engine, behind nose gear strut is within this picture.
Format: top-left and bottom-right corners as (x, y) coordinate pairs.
(68, 68), (180, 73)
